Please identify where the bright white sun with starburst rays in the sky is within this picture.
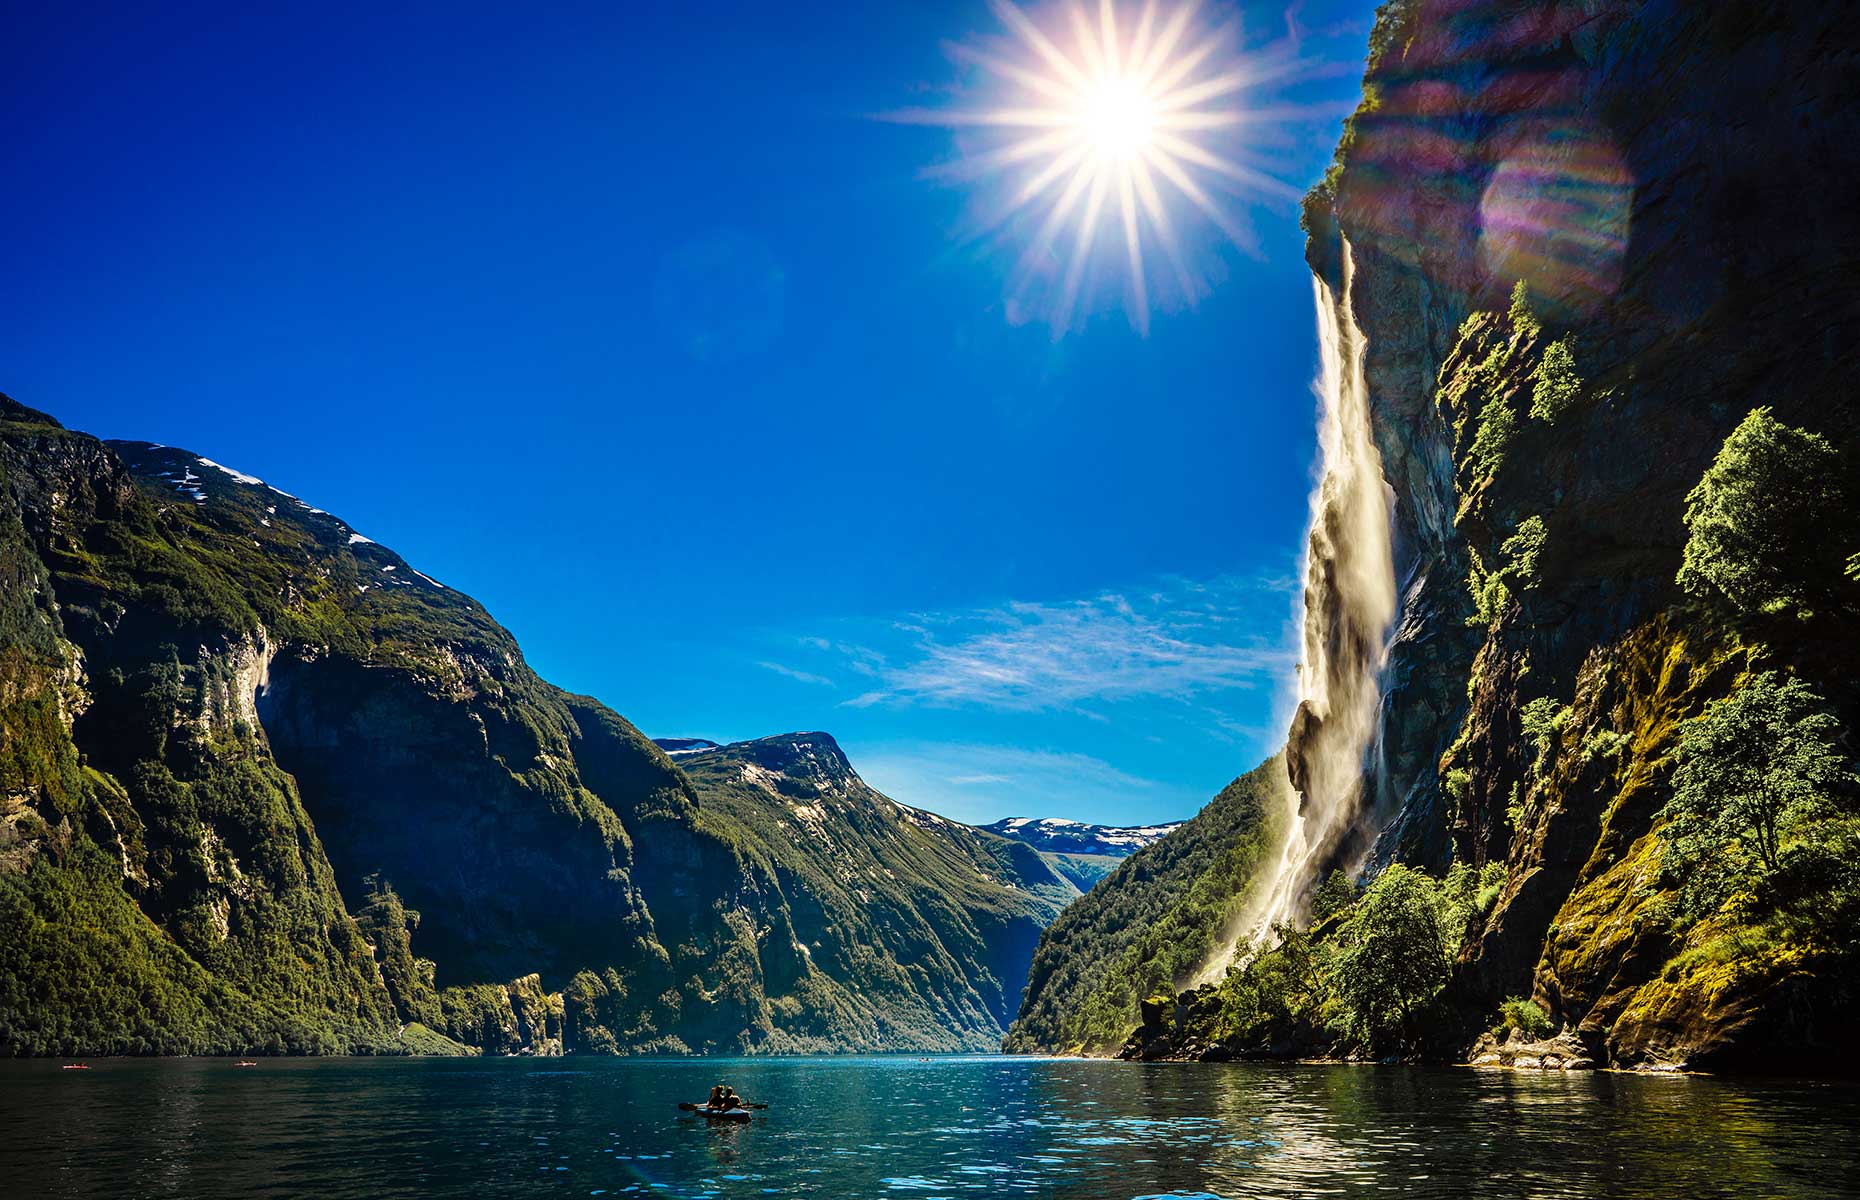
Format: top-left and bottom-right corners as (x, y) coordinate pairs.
(887, 0), (1300, 337)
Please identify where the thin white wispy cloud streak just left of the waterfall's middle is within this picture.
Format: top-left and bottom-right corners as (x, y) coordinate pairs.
(830, 579), (1293, 713)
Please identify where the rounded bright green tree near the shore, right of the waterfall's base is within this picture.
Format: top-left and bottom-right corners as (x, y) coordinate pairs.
(1330, 863), (1449, 1047)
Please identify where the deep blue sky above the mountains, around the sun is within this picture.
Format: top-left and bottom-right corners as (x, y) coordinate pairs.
(0, 0), (1373, 822)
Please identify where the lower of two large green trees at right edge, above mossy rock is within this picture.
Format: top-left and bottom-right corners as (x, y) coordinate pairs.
(1661, 672), (1853, 917)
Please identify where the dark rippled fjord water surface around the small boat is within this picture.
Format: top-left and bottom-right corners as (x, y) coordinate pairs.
(0, 1059), (1860, 1200)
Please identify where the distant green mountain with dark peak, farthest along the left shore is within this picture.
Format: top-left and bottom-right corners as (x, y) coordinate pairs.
(681, 733), (1079, 1051)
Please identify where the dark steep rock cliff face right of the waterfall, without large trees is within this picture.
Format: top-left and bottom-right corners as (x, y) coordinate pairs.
(1306, 0), (1860, 1064)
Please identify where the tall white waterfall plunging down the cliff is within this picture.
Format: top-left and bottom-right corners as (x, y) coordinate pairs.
(1192, 242), (1395, 984)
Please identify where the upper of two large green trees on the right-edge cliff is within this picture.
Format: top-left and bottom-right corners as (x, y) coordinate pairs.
(1678, 407), (1851, 612)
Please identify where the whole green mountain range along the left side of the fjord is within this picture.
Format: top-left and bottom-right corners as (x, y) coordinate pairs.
(0, 398), (1073, 1055)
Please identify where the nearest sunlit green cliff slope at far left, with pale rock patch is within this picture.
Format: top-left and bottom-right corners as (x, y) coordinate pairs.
(0, 398), (398, 1053)
